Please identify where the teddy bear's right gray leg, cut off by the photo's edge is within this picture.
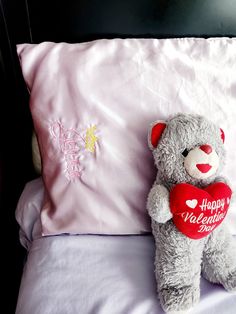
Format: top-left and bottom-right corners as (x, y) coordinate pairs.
(202, 224), (236, 292)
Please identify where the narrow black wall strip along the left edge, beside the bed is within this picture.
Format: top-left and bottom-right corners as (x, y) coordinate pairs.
(0, 0), (35, 313)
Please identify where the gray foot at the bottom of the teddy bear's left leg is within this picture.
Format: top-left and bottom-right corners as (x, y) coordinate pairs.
(160, 286), (197, 314)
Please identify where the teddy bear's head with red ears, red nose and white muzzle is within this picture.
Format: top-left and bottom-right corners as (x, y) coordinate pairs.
(148, 114), (225, 186)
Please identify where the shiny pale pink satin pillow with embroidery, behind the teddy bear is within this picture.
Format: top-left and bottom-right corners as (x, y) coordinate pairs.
(17, 38), (236, 235)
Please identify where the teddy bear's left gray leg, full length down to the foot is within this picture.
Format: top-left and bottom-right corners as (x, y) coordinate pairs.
(152, 221), (204, 314)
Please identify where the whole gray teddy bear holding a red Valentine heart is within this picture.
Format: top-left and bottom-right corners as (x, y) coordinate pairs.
(147, 114), (236, 314)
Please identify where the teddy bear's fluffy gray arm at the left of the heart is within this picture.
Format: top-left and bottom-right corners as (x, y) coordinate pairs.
(147, 185), (172, 223)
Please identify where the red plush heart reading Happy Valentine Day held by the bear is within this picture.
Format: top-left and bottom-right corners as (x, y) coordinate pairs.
(170, 182), (232, 239)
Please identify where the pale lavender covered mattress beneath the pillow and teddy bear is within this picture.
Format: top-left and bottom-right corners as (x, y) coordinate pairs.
(16, 179), (236, 314)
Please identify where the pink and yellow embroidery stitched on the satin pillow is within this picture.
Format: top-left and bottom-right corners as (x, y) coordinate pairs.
(50, 122), (98, 180)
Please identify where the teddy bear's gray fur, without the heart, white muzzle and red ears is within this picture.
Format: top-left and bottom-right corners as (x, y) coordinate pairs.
(147, 114), (236, 313)
